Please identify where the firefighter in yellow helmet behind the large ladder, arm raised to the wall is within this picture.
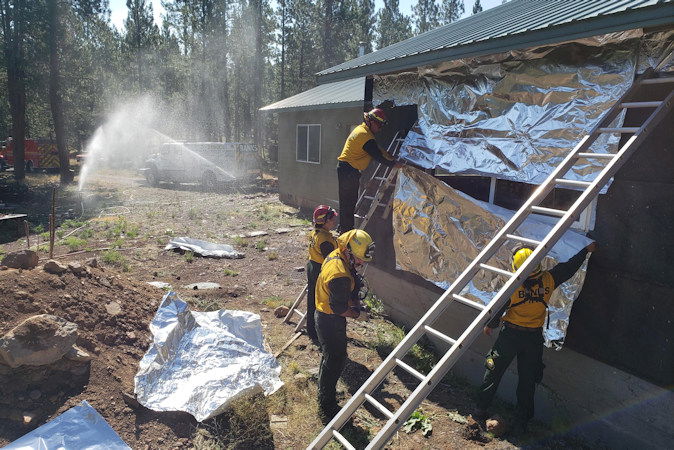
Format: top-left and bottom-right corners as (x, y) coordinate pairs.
(475, 242), (597, 433)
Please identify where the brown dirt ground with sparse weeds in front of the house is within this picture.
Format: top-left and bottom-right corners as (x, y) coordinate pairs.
(0, 172), (586, 449)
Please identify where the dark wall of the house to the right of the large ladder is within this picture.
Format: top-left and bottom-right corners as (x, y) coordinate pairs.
(567, 84), (674, 386)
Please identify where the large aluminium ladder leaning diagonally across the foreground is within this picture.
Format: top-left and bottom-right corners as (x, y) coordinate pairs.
(308, 65), (674, 449)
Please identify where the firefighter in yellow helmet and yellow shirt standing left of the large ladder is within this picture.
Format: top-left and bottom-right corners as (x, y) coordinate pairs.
(315, 230), (374, 423)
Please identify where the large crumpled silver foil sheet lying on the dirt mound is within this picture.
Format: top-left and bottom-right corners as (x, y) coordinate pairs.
(135, 292), (283, 422)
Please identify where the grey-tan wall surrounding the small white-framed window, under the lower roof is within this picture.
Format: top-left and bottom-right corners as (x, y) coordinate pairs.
(278, 107), (363, 210)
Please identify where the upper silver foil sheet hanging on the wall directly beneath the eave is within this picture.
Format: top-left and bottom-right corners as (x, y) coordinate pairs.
(373, 30), (671, 190)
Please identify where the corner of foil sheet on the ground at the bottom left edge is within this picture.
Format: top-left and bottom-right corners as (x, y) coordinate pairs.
(3, 401), (131, 450)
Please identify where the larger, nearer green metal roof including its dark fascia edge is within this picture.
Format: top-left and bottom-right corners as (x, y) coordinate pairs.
(318, 0), (674, 83)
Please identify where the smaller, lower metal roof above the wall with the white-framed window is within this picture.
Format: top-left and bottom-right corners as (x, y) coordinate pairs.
(260, 77), (365, 112)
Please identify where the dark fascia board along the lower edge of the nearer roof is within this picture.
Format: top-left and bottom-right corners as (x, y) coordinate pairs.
(317, 3), (674, 84)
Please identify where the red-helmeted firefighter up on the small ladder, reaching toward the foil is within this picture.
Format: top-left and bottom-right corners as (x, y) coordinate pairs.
(337, 108), (402, 233)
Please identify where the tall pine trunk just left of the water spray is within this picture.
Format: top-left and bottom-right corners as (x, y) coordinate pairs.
(47, 0), (73, 184)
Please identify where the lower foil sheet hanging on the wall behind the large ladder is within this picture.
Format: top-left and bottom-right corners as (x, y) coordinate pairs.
(393, 166), (592, 350)
